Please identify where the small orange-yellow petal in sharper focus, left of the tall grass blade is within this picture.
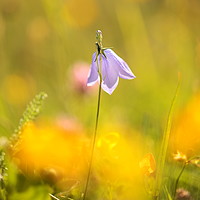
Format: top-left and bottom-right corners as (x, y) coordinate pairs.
(139, 153), (156, 176)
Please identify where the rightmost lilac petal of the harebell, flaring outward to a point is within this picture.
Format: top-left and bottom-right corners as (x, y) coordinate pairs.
(104, 49), (136, 79)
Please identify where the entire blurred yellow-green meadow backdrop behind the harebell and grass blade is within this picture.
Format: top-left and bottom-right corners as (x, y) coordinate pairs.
(0, 0), (200, 200)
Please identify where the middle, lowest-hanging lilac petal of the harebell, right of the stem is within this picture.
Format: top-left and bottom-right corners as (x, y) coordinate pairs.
(102, 56), (119, 94)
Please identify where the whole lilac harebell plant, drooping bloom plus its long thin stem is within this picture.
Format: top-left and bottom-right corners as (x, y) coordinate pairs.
(83, 30), (135, 200)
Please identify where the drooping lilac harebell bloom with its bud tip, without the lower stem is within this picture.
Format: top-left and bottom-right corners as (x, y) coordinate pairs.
(87, 31), (136, 94)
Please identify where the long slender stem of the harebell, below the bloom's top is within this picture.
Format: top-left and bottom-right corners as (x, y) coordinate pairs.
(83, 55), (102, 200)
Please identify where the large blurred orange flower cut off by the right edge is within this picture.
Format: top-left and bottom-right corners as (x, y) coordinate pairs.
(171, 94), (200, 157)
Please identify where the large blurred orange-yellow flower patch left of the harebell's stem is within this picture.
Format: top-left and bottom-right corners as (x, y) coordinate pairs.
(12, 120), (88, 182)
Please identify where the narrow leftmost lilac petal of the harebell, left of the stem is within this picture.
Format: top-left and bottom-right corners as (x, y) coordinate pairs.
(87, 53), (99, 86)
